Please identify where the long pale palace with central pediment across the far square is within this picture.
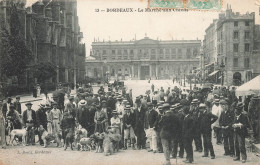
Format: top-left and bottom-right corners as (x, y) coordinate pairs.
(86, 37), (201, 80)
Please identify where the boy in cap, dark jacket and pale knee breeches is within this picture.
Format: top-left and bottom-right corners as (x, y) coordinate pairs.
(123, 107), (135, 150)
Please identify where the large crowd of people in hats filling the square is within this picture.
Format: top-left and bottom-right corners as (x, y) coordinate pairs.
(0, 84), (258, 165)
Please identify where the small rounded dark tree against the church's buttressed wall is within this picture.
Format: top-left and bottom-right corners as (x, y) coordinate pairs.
(32, 62), (57, 83)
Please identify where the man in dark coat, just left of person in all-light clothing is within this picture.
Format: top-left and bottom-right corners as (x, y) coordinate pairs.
(36, 104), (47, 145)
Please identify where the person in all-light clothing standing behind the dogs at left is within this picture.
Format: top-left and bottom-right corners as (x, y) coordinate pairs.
(50, 102), (62, 135)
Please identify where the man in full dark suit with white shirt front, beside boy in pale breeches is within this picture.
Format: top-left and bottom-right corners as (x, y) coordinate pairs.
(134, 98), (146, 150)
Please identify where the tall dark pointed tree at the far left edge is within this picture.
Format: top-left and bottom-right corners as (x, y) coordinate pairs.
(0, 4), (32, 78)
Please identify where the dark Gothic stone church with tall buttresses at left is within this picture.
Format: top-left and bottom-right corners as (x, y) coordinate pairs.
(0, 0), (85, 90)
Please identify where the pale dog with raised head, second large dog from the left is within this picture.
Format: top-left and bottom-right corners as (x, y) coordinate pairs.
(39, 126), (61, 148)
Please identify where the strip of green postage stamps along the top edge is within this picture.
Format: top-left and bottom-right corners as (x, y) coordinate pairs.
(148, 0), (222, 10)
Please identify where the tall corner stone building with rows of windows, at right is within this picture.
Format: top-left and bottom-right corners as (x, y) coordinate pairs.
(203, 6), (260, 85)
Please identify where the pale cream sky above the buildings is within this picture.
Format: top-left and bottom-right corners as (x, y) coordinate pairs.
(33, 0), (260, 56)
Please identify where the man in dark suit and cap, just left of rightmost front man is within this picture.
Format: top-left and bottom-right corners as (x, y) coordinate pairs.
(219, 100), (234, 157)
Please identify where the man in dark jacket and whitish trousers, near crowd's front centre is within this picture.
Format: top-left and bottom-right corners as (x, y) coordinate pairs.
(145, 102), (158, 153)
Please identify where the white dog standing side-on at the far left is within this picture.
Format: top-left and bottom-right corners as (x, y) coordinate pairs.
(9, 127), (28, 146)
